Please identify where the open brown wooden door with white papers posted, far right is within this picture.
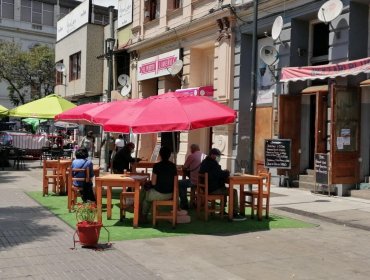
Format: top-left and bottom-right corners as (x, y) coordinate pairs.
(330, 87), (361, 184)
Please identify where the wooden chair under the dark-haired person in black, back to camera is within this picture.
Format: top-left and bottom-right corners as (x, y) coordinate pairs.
(152, 175), (179, 228)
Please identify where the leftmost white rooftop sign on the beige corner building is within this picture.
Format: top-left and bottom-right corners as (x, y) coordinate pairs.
(57, 0), (90, 41)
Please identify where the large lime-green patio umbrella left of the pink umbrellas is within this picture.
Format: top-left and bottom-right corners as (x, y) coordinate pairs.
(9, 94), (76, 119)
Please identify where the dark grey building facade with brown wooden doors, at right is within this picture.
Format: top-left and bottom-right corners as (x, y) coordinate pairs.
(233, 0), (370, 195)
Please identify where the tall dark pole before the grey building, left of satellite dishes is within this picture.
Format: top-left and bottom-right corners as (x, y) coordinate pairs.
(248, 0), (258, 174)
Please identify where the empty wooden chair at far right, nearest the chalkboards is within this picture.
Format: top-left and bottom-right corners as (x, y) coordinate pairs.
(240, 172), (271, 218)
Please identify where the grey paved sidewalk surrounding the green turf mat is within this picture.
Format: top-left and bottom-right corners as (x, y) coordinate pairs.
(0, 161), (370, 280)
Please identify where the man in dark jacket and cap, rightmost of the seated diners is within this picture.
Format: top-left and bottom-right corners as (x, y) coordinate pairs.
(199, 148), (245, 220)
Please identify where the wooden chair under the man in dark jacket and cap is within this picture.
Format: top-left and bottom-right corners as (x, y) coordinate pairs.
(197, 173), (225, 221)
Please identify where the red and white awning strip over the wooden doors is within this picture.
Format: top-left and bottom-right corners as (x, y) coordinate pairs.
(280, 57), (370, 82)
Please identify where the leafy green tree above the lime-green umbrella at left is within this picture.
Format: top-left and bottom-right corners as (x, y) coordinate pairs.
(0, 42), (55, 106)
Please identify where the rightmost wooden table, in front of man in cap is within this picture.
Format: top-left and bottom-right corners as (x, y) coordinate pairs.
(227, 174), (263, 220)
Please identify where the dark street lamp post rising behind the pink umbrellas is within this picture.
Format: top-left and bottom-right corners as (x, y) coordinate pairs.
(104, 6), (114, 172)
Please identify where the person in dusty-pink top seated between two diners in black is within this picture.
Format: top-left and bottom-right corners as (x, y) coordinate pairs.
(179, 144), (205, 210)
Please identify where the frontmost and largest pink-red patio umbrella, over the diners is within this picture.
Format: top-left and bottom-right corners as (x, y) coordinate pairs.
(103, 92), (236, 133)
